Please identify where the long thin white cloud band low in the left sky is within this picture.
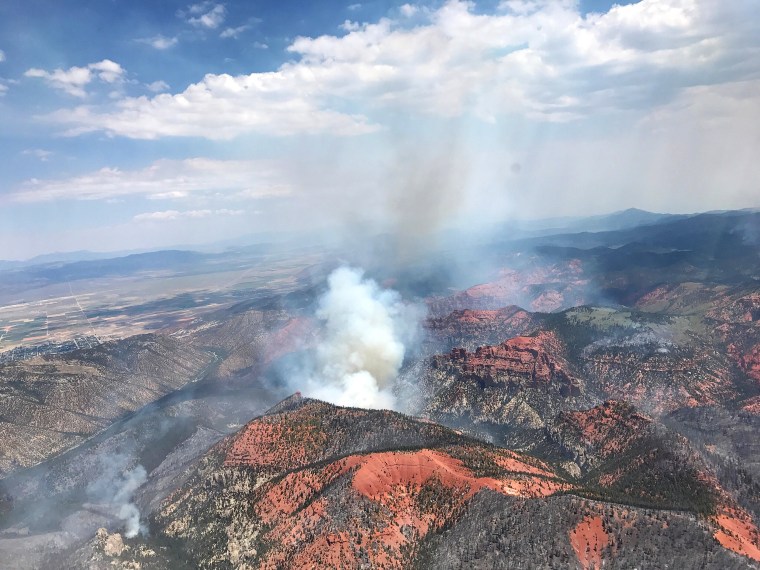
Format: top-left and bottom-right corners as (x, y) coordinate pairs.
(11, 158), (290, 202)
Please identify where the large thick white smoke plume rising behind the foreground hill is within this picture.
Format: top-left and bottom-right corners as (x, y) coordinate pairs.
(304, 267), (418, 409)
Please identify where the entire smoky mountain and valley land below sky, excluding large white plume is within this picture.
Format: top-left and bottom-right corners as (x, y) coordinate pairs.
(0, 213), (760, 569)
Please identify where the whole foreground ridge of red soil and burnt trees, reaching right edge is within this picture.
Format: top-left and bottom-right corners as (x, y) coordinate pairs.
(68, 396), (760, 569)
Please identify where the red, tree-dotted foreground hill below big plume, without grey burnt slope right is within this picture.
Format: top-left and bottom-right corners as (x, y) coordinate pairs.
(140, 398), (571, 568)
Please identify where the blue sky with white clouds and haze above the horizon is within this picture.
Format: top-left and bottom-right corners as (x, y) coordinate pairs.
(0, 0), (760, 259)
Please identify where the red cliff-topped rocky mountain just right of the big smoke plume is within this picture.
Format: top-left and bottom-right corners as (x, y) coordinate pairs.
(405, 330), (598, 445)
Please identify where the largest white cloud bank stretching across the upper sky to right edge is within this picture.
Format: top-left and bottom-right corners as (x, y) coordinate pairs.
(32, 0), (760, 135)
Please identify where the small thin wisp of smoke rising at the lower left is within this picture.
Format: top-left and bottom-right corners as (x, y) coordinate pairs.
(87, 455), (148, 538)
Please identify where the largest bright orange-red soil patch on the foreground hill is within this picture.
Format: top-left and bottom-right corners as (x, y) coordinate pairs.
(255, 448), (569, 568)
